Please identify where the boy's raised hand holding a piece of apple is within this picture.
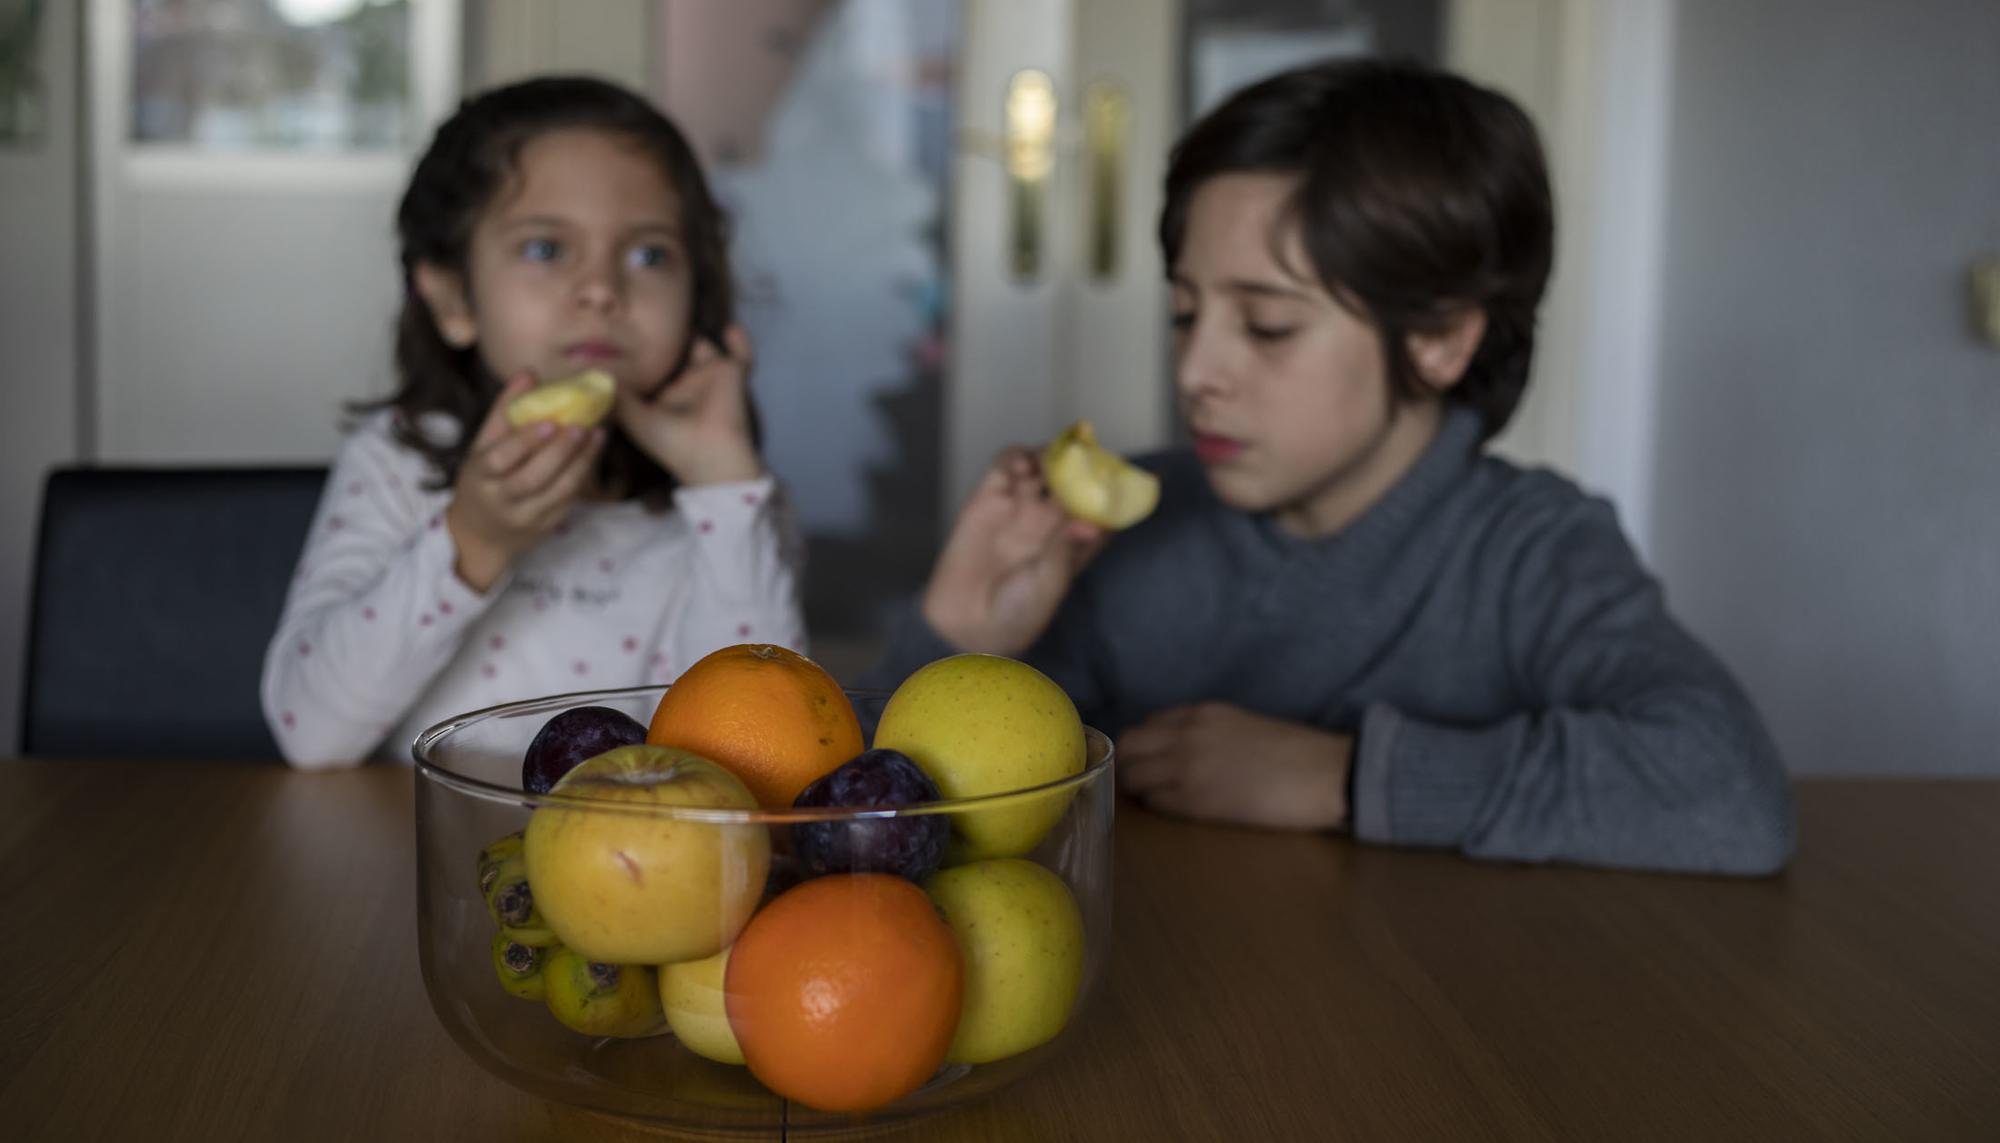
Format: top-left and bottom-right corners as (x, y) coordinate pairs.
(924, 448), (1106, 655)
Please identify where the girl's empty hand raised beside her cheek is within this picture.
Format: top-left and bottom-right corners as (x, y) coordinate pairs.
(616, 326), (764, 486)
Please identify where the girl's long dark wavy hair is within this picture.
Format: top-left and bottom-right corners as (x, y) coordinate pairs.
(354, 76), (756, 502)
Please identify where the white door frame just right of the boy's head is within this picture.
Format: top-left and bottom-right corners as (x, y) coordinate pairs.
(1444, 0), (1674, 554)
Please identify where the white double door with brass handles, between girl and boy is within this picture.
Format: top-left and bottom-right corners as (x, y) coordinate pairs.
(940, 0), (1182, 520)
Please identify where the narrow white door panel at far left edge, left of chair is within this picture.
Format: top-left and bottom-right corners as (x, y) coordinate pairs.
(0, 4), (78, 753)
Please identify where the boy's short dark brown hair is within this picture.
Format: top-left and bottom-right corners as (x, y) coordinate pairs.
(1160, 60), (1556, 438)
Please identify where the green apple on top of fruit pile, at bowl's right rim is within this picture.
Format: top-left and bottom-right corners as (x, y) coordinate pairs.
(874, 653), (1086, 861)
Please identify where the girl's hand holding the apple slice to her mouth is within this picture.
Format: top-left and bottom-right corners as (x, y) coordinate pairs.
(444, 374), (604, 591)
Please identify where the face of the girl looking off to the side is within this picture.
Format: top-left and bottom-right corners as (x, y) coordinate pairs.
(426, 128), (694, 394)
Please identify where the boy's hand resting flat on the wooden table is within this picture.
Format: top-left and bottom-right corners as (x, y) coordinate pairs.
(1118, 703), (1354, 829)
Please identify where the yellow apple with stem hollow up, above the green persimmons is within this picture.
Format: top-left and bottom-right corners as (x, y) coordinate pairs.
(522, 743), (770, 965)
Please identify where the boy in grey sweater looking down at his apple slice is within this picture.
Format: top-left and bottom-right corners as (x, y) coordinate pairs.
(870, 62), (1792, 873)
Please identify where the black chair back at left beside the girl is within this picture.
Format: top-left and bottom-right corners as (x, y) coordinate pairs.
(20, 468), (326, 759)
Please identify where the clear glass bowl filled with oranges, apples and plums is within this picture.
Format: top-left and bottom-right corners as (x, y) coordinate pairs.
(416, 653), (1114, 1133)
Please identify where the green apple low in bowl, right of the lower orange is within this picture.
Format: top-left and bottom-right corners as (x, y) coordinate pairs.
(924, 857), (1084, 1063)
